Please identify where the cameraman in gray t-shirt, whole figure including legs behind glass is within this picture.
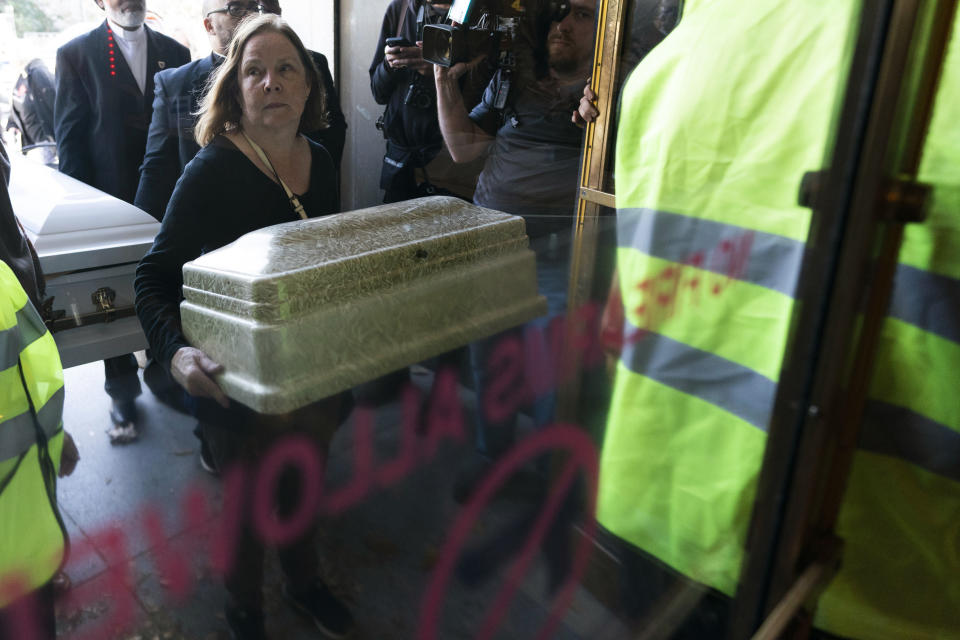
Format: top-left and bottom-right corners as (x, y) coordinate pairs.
(434, 0), (596, 499)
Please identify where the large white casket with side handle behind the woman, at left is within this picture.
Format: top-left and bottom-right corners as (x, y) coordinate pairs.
(10, 154), (160, 367)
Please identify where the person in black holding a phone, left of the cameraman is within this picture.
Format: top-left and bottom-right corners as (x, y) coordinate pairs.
(370, 0), (477, 202)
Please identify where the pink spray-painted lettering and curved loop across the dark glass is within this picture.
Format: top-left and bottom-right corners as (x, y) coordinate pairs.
(0, 304), (603, 640)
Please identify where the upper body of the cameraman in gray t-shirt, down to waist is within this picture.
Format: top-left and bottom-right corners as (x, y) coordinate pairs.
(434, 0), (596, 238)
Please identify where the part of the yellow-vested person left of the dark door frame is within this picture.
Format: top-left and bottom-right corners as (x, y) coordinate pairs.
(597, 1), (857, 637)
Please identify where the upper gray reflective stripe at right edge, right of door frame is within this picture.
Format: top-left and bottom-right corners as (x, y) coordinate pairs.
(890, 264), (960, 343)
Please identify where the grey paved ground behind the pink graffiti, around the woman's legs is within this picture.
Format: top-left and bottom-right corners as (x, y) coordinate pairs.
(52, 362), (627, 640)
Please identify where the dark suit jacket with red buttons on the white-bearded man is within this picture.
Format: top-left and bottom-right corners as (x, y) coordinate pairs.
(54, 20), (190, 203)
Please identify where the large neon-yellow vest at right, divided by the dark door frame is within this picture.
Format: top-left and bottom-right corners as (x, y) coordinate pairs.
(598, 0), (960, 638)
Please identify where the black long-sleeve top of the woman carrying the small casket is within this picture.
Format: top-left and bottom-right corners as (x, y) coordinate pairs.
(134, 136), (340, 370)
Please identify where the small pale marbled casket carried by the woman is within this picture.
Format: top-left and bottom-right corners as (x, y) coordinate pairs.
(180, 197), (547, 414)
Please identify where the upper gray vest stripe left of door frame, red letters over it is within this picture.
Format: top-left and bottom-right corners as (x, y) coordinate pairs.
(617, 208), (804, 297)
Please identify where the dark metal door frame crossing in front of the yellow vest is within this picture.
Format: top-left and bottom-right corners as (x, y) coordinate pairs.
(729, 0), (957, 638)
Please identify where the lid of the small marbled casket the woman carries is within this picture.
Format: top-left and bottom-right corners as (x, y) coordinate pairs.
(183, 196), (527, 320)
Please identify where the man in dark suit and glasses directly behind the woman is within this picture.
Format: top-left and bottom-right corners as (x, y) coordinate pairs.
(134, 0), (347, 220)
